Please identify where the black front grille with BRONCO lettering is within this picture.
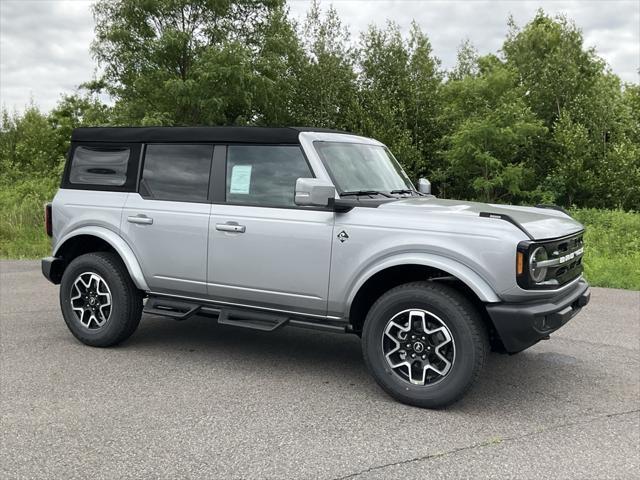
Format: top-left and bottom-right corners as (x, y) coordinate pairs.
(542, 232), (584, 286)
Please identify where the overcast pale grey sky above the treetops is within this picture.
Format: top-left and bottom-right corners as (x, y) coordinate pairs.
(0, 0), (640, 110)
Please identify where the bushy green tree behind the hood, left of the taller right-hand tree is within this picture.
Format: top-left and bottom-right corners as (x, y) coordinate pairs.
(443, 56), (547, 202)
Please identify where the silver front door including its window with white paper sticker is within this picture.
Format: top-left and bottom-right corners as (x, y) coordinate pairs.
(208, 145), (334, 315)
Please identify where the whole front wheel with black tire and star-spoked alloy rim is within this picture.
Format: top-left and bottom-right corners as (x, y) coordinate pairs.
(362, 282), (489, 408)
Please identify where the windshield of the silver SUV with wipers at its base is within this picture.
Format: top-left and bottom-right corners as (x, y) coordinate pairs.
(314, 142), (414, 194)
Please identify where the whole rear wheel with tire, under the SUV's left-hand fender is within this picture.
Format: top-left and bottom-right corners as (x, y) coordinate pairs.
(60, 252), (143, 347)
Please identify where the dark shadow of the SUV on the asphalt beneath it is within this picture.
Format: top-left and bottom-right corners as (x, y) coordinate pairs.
(122, 315), (608, 416)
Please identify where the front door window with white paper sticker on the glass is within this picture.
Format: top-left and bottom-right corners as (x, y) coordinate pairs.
(226, 145), (313, 207)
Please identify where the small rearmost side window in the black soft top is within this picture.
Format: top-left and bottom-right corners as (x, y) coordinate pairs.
(69, 146), (131, 187)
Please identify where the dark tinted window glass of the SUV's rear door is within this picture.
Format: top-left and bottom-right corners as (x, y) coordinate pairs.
(140, 145), (213, 202)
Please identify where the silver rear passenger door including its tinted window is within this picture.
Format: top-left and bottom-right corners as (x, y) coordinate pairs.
(122, 144), (213, 297)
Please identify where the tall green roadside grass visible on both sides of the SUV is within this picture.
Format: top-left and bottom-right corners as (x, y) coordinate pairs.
(0, 182), (640, 290)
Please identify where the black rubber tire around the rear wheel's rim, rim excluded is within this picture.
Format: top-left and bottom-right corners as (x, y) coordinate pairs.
(60, 255), (129, 344)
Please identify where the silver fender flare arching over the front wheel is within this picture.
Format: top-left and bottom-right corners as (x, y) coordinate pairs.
(346, 253), (501, 312)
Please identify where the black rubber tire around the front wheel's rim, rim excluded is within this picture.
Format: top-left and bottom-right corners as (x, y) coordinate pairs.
(363, 287), (478, 407)
